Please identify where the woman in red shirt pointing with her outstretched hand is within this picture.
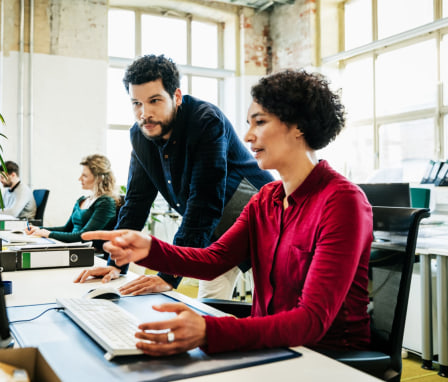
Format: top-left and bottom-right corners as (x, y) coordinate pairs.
(83, 70), (372, 356)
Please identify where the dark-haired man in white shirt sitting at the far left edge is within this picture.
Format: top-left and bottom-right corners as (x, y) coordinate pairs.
(0, 161), (36, 219)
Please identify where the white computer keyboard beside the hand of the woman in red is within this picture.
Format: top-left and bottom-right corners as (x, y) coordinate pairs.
(56, 298), (143, 361)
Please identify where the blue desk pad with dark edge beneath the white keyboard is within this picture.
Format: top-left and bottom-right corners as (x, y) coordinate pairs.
(8, 294), (300, 382)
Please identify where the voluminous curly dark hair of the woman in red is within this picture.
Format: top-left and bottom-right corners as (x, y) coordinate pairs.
(251, 70), (345, 150)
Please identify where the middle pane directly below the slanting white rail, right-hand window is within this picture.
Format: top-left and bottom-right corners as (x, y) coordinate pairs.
(376, 40), (437, 115)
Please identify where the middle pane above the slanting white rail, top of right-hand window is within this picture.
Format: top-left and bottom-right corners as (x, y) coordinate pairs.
(378, 0), (434, 39)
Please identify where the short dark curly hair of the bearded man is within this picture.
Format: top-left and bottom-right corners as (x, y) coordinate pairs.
(123, 54), (180, 97)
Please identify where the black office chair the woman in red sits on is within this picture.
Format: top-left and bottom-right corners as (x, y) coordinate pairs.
(201, 206), (430, 382)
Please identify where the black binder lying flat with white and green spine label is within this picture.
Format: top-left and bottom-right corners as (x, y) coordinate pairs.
(16, 247), (95, 270)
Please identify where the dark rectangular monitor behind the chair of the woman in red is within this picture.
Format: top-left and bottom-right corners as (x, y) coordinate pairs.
(358, 183), (411, 207)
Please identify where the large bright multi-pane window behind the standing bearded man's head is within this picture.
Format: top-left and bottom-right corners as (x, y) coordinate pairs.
(107, 9), (229, 185)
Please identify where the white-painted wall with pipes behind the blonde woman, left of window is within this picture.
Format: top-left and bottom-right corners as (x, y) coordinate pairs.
(1, 52), (107, 225)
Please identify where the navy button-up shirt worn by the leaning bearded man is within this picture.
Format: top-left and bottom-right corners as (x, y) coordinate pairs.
(110, 95), (273, 281)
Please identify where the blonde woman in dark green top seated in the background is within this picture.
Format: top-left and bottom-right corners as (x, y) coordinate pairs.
(26, 154), (118, 243)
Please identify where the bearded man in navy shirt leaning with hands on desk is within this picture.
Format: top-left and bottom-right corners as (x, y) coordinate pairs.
(76, 55), (273, 298)
